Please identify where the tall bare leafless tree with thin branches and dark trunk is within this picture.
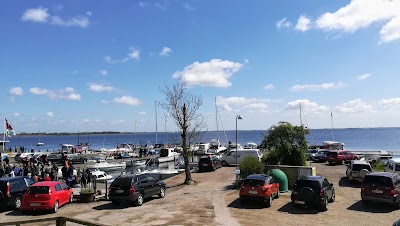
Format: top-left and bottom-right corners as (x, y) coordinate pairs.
(160, 80), (206, 184)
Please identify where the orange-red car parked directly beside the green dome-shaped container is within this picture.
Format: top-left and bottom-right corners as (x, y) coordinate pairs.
(239, 174), (280, 207)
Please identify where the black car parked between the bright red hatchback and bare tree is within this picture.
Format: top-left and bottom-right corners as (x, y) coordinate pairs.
(108, 174), (166, 206)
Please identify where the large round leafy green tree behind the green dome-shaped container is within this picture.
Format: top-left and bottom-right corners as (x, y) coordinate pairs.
(260, 122), (309, 166)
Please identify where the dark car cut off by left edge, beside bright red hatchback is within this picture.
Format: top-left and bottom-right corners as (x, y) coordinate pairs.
(0, 176), (35, 209)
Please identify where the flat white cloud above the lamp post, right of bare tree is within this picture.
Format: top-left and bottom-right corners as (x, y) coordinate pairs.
(216, 97), (280, 111)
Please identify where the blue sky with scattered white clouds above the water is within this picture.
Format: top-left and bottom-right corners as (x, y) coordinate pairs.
(0, 0), (400, 133)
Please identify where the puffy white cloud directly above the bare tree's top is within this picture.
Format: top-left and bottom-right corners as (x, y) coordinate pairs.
(172, 59), (243, 87)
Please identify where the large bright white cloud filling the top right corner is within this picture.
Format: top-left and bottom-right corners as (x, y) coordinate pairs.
(315, 0), (400, 42)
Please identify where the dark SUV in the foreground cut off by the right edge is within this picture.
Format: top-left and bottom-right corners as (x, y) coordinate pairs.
(361, 172), (400, 209)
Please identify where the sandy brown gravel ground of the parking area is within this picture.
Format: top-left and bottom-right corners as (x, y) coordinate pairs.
(0, 163), (400, 226)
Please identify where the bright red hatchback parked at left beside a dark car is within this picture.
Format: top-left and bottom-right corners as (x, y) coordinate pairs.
(21, 181), (73, 213)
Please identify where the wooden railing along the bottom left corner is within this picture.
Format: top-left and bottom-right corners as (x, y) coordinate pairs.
(0, 217), (106, 226)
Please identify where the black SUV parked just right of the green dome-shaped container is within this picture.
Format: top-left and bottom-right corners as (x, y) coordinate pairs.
(291, 176), (336, 211)
